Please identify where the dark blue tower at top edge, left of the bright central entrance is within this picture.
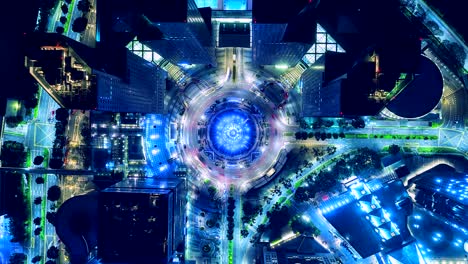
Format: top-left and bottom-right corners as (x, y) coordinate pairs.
(98, 0), (216, 65)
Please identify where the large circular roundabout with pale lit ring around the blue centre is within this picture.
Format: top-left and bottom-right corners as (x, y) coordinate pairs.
(179, 83), (286, 185)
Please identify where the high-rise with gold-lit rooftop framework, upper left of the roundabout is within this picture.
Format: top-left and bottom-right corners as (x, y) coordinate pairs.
(26, 34), (167, 113)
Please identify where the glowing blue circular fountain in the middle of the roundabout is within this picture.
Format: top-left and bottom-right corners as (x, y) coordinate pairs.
(209, 110), (257, 157)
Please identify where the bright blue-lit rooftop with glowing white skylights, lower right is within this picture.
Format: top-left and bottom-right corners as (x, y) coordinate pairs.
(324, 180), (412, 258)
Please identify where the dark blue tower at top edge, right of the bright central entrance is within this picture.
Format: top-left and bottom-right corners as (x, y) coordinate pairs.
(252, 0), (316, 66)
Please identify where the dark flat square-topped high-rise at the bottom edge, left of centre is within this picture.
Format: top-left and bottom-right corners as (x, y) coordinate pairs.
(98, 178), (186, 263)
